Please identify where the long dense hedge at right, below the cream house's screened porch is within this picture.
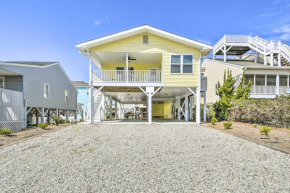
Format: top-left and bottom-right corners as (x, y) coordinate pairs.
(228, 96), (290, 128)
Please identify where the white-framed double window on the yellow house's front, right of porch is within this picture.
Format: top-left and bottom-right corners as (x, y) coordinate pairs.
(171, 55), (193, 74)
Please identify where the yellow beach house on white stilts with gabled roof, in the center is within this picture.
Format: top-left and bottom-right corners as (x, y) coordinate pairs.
(76, 25), (212, 123)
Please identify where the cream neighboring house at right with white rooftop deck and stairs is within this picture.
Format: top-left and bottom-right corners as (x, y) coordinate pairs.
(202, 35), (290, 103)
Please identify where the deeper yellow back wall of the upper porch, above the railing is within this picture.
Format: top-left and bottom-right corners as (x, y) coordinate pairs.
(102, 62), (161, 70)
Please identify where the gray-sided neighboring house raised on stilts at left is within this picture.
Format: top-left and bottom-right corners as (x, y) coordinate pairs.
(0, 62), (77, 131)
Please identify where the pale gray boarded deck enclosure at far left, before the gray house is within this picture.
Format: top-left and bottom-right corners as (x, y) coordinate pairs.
(0, 88), (24, 132)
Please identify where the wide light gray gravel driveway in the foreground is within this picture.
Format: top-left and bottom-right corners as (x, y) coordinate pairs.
(0, 124), (290, 193)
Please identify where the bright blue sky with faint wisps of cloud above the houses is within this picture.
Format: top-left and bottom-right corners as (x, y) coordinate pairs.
(0, 0), (290, 81)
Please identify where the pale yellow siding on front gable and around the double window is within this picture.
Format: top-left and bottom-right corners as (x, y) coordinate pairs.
(90, 33), (199, 87)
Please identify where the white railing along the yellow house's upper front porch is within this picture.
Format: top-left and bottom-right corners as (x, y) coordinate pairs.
(92, 70), (163, 83)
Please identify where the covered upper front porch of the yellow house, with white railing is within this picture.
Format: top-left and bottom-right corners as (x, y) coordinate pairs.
(91, 52), (163, 86)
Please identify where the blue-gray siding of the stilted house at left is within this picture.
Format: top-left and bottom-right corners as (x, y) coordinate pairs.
(0, 63), (77, 110)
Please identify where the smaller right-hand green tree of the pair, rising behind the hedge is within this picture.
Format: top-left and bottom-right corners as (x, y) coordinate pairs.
(234, 72), (252, 100)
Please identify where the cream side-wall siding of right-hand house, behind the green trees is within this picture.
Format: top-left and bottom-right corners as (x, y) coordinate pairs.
(202, 59), (243, 103)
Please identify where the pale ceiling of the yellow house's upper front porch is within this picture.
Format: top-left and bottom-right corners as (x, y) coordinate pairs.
(94, 52), (162, 64)
